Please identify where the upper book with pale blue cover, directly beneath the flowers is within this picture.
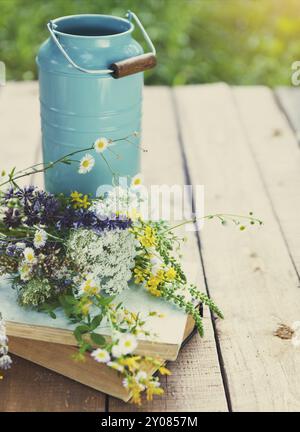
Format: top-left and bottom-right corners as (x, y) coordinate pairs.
(0, 278), (191, 360)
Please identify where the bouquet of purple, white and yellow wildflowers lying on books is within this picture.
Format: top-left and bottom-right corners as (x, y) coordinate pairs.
(0, 133), (260, 404)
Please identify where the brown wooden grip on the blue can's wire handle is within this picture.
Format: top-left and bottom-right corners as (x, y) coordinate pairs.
(110, 53), (157, 78)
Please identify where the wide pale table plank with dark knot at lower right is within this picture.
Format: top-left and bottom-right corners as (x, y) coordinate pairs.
(175, 84), (300, 411)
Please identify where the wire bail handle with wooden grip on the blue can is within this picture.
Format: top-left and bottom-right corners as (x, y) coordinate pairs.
(47, 11), (157, 78)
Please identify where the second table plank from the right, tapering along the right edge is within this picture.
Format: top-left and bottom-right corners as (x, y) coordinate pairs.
(234, 87), (300, 275)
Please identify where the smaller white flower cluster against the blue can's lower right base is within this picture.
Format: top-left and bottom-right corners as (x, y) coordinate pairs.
(91, 186), (143, 220)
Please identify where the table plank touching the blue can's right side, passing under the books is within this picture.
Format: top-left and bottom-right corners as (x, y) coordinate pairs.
(109, 87), (227, 412)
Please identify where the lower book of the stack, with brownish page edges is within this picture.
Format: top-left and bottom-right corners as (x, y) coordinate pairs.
(9, 317), (195, 402)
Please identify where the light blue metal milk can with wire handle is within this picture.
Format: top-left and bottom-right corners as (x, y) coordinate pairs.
(37, 12), (156, 194)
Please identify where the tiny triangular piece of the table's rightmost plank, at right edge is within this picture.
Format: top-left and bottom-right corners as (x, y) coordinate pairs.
(275, 87), (300, 143)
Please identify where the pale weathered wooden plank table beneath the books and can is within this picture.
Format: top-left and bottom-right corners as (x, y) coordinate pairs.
(0, 82), (300, 412)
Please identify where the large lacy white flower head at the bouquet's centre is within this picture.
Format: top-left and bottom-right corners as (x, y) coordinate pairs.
(67, 229), (136, 294)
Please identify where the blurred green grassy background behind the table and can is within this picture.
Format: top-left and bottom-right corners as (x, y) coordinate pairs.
(0, 0), (300, 86)
